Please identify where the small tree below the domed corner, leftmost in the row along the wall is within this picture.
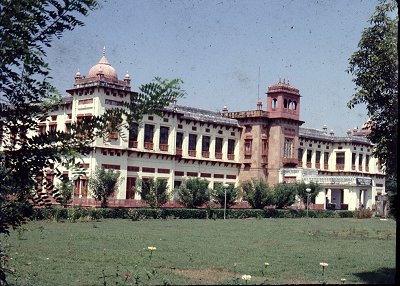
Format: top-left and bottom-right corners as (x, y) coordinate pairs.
(89, 167), (120, 208)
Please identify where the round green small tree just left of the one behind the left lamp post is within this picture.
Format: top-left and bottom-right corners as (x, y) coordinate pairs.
(175, 178), (210, 208)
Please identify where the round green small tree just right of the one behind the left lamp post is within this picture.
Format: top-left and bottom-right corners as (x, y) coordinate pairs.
(241, 178), (273, 209)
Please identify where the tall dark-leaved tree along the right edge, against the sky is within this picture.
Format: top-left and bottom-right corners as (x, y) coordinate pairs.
(347, 0), (399, 219)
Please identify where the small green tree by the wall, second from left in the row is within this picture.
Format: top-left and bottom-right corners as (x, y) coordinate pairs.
(135, 178), (170, 208)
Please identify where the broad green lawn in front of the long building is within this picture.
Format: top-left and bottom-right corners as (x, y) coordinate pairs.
(1, 218), (396, 285)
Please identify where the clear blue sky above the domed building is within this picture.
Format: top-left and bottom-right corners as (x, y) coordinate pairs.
(47, 0), (378, 136)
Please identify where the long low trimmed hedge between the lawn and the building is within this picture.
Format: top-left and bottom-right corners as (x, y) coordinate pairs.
(31, 207), (360, 222)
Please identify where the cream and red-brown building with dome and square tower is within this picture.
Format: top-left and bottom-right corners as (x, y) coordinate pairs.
(3, 51), (385, 210)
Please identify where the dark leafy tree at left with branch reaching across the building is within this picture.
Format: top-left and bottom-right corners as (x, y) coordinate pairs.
(0, 0), (183, 236)
